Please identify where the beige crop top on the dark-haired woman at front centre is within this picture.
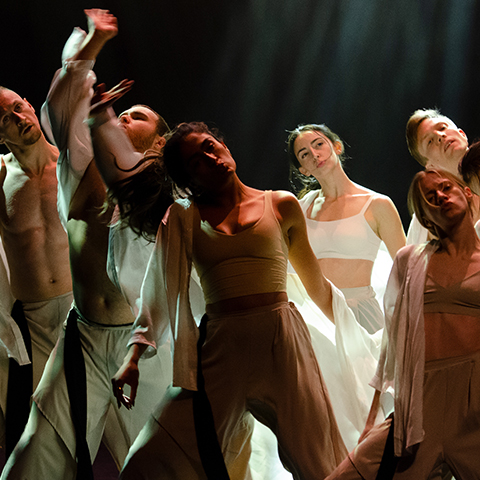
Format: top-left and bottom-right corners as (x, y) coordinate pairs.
(193, 191), (288, 304)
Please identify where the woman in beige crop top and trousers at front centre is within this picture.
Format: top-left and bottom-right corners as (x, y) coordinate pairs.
(110, 123), (345, 478)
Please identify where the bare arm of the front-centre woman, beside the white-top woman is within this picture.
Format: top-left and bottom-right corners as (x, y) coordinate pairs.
(274, 192), (334, 322)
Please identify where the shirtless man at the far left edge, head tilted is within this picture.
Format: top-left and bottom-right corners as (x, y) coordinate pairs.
(0, 87), (72, 455)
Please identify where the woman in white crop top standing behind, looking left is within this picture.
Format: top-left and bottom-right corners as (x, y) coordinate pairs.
(287, 124), (405, 333)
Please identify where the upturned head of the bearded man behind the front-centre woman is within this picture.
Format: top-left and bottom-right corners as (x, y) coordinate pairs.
(118, 105), (170, 153)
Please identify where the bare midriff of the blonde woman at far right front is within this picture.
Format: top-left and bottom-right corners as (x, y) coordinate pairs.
(424, 312), (480, 361)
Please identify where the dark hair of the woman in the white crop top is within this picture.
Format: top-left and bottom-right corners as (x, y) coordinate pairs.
(287, 123), (348, 198)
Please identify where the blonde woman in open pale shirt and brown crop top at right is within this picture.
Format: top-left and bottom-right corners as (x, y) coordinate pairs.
(328, 170), (480, 480)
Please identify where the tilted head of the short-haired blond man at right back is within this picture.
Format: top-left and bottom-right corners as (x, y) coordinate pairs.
(405, 109), (468, 173)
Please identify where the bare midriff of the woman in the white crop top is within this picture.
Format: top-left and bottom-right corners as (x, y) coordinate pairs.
(318, 258), (373, 288)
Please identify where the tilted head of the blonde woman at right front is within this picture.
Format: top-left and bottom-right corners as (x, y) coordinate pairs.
(408, 169), (473, 238)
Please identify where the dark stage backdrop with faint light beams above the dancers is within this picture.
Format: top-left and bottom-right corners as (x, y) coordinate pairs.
(0, 0), (480, 230)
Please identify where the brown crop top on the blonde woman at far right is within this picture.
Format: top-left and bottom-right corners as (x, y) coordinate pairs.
(423, 271), (480, 317)
